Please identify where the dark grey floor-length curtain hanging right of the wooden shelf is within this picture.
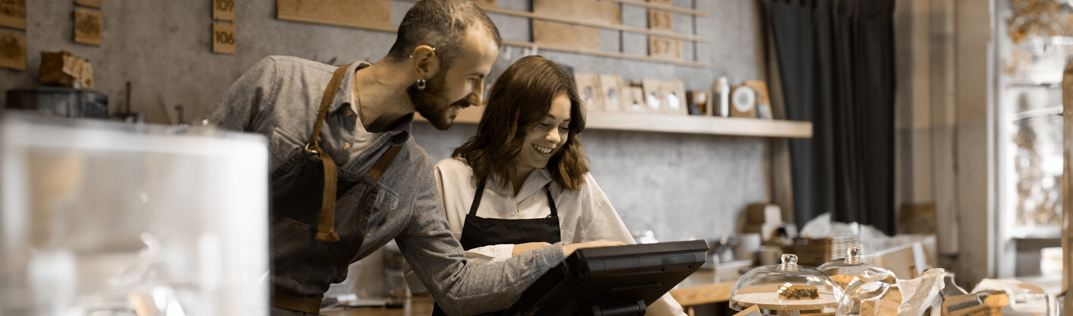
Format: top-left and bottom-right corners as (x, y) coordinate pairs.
(761, 0), (895, 235)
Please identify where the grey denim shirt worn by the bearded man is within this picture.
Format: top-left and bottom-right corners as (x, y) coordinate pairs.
(207, 56), (563, 315)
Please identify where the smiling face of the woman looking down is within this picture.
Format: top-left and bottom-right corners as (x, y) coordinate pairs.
(514, 93), (570, 171)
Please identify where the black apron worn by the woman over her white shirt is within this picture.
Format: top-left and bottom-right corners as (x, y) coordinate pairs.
(432, 181), (562, 316)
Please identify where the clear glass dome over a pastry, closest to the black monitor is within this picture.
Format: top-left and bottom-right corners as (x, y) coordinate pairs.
(730, 254), (842, 315)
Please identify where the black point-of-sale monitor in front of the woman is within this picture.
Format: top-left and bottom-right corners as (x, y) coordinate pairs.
(504, 240), (708, 316)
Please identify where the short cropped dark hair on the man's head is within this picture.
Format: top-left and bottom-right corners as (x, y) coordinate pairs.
(387, 0), (503, 67)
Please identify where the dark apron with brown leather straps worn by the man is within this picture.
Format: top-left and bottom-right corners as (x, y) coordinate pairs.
(269, 65), (402, 315)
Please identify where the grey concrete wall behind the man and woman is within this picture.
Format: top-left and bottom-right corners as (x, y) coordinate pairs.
(0, 0), (769, 240)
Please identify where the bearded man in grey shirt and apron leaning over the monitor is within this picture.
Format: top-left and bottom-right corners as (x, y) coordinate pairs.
(208, 0), (622, 315)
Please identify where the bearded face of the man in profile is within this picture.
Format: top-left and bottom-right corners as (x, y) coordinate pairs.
(407, 27), (499, 130)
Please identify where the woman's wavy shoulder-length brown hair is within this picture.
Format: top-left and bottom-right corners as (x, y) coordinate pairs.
(451, 56), (589, 190)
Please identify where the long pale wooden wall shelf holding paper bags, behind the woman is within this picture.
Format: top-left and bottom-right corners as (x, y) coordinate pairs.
(415, 106), (812, 138)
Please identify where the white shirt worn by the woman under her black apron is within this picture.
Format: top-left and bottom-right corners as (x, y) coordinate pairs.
(435, 159), (686, 316)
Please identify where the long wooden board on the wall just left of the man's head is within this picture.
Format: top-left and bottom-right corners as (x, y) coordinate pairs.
(276, 0), (395, 32)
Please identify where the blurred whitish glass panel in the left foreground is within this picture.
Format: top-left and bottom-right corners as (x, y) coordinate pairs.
(0, 112), (268, 316)
